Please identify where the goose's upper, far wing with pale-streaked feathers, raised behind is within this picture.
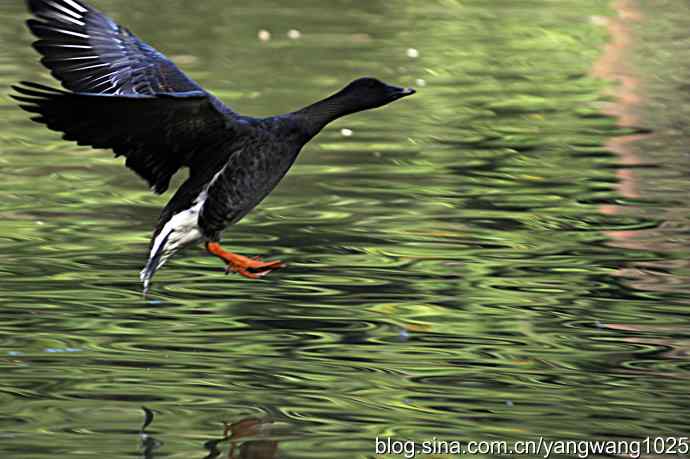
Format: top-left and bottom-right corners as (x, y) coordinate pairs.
(27, 0), (202, 95)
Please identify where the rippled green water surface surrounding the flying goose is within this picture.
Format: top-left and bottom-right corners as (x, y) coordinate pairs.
(0, 0), (690, 459)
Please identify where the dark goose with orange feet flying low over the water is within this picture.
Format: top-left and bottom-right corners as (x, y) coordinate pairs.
(13, 0), (415, 291)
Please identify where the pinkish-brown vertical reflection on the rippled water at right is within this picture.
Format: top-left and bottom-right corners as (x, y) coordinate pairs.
(592, 0), (690, 304)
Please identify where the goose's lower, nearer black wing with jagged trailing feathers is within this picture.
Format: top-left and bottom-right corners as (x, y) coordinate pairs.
(11, 82), (233, 193)
